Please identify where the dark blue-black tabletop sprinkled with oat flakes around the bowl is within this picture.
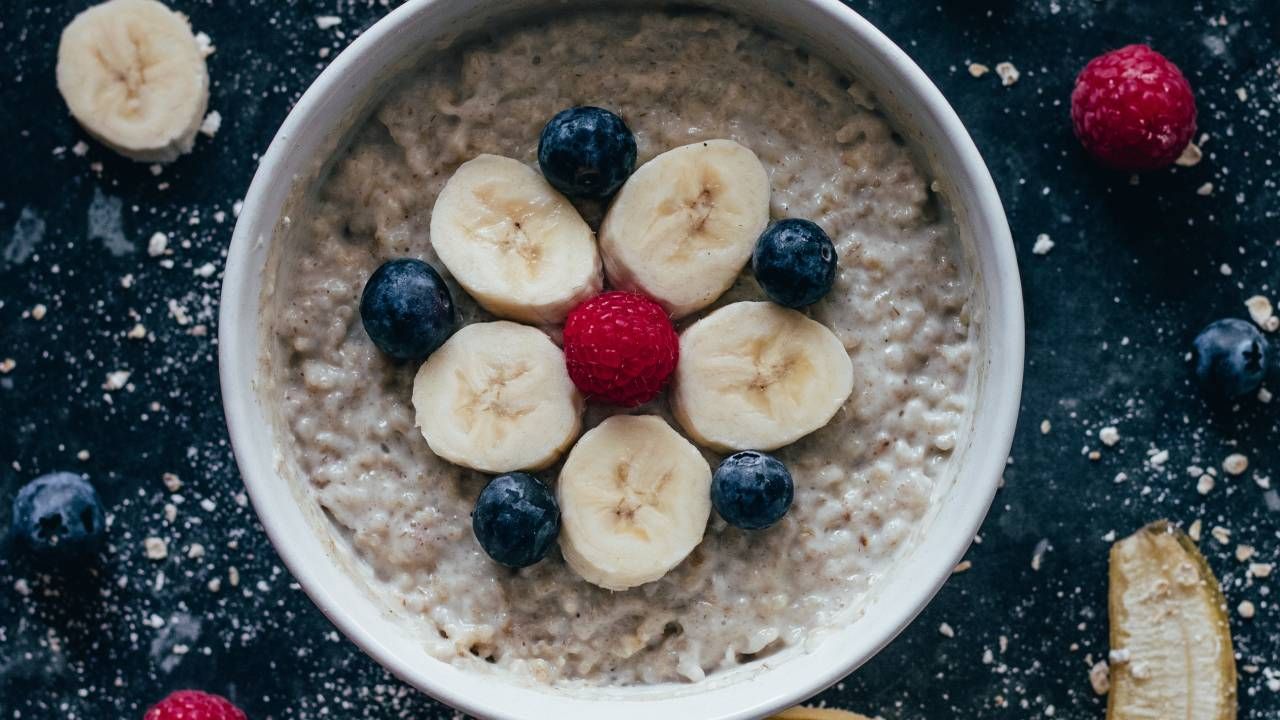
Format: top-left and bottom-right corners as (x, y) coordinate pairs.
(0, 0), (1280, 720)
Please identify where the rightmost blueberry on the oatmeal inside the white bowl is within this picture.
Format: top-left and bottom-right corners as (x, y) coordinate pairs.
(751, 219), (836, 307)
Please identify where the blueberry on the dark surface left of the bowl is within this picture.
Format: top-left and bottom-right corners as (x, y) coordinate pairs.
(13, 473), (106, 555)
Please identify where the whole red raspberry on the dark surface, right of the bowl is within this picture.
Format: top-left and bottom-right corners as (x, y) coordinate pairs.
(1071, 45), (1196, 172)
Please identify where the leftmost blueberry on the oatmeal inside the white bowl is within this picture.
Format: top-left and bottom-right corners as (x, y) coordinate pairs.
(360, 258), (457, 360)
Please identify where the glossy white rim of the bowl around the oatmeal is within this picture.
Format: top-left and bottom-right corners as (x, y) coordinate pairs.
(218, 0), (1025, 720)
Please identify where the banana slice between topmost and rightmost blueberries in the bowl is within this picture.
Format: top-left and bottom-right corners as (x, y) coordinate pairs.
(600, 140), (769, 318)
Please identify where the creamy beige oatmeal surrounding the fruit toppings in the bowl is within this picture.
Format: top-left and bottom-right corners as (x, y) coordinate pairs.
(266, 13), (975, 685)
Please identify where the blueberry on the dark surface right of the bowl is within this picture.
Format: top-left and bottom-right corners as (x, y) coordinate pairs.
(1193, 318), (1268, 401)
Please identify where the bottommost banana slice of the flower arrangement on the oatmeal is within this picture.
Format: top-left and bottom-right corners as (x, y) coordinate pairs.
(556, 415), (712, 591)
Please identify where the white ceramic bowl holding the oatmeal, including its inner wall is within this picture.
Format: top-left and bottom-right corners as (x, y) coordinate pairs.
(219, 0), (1023, 720)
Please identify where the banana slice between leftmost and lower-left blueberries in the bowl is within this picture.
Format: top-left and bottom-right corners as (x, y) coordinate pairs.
(413, 320), (582, 473)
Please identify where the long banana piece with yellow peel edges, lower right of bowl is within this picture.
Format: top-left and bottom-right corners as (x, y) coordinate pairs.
(1107, 520), (1236, 720)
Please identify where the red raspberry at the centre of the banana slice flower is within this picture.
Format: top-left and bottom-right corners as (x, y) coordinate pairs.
(564, 292), (680, 407)
